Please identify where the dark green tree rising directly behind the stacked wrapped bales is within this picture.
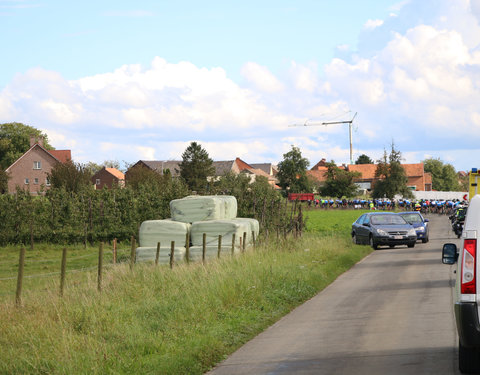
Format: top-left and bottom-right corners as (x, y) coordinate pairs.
(179, 142), (215, 192)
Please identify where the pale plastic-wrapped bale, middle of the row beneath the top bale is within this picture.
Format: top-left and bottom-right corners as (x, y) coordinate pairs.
(190, 219), (250, 247)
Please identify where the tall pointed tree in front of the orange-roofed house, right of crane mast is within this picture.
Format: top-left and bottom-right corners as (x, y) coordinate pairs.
(372, 142), (413, 199)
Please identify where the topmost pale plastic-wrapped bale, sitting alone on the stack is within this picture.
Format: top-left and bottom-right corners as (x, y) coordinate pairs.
(170, 195), (237, 223)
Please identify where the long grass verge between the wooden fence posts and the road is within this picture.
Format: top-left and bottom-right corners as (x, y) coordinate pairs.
(0, 211), (371, 374)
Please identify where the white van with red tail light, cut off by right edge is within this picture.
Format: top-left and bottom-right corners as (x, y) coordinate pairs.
(442, 195), (480, 373)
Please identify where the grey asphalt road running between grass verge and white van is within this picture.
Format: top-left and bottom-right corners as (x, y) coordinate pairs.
(209, 215), (460, 375)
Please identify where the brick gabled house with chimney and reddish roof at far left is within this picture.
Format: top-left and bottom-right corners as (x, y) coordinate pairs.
(5, 137), (72, 194)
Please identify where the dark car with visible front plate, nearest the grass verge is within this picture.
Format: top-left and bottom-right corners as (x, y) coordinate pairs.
(351, 212), (417, 250)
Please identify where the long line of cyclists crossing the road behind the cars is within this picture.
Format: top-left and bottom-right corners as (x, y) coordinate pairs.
(307, 198), (465, 215)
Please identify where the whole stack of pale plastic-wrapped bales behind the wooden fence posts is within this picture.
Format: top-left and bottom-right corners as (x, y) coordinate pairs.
(137, 195), (259, 262)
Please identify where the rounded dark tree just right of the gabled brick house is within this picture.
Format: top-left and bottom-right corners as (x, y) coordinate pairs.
(48, 160), (92, 192)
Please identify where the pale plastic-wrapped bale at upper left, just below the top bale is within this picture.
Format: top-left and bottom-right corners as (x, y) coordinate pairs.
(139, 219), (191, 247)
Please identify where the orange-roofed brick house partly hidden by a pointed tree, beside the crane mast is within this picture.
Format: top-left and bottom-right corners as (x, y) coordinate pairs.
(348, 163), (432, 191)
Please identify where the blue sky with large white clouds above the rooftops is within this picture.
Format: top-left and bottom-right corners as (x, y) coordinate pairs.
(0, 0), (480, 170)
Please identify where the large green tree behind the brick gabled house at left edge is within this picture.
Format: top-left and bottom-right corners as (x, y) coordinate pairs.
(0, 122), (53, 169)
